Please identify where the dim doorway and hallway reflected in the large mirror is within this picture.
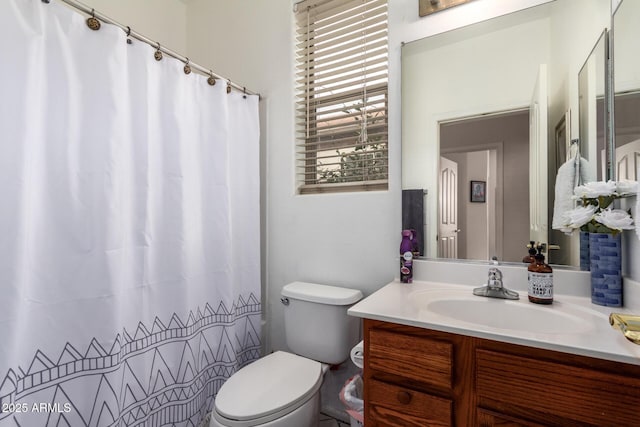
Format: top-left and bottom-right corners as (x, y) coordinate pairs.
(438, 109), (529, 262)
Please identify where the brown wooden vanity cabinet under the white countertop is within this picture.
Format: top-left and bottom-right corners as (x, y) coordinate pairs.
(364, 319), (640, 427)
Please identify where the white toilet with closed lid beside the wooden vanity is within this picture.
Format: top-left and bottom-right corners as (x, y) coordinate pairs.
(209, 282), (362, 427)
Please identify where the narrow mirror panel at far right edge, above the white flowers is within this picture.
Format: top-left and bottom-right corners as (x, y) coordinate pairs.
(613, 0), (640, 180)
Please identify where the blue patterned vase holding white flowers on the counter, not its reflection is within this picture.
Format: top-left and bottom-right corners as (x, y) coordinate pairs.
(589, 233), (622, 307)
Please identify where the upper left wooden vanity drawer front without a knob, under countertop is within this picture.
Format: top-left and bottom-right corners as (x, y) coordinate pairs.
(367, 329), (453, 390)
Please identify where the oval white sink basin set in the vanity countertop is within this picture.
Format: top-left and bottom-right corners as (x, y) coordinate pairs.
(409, 290), (603, 334)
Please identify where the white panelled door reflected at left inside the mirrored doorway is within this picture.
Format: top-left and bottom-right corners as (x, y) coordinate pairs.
(438, 157), (460, 258)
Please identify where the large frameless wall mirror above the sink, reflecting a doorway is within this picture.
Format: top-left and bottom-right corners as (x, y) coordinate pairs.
(402, 0), (611, 265)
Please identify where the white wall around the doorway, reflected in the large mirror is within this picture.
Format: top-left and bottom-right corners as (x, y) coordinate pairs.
(402, 0), (610, 265)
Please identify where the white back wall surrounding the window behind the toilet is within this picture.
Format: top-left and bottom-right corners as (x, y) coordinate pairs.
(182, 0), (401, 358)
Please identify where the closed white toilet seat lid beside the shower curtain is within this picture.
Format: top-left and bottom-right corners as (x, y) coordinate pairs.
(214, 351), (323, 427)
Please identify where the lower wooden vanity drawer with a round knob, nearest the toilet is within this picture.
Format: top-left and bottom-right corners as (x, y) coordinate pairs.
(366, 379), (453, 426)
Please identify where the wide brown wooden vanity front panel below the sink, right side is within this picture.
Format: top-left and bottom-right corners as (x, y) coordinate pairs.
(476, 349), (640, 426)
